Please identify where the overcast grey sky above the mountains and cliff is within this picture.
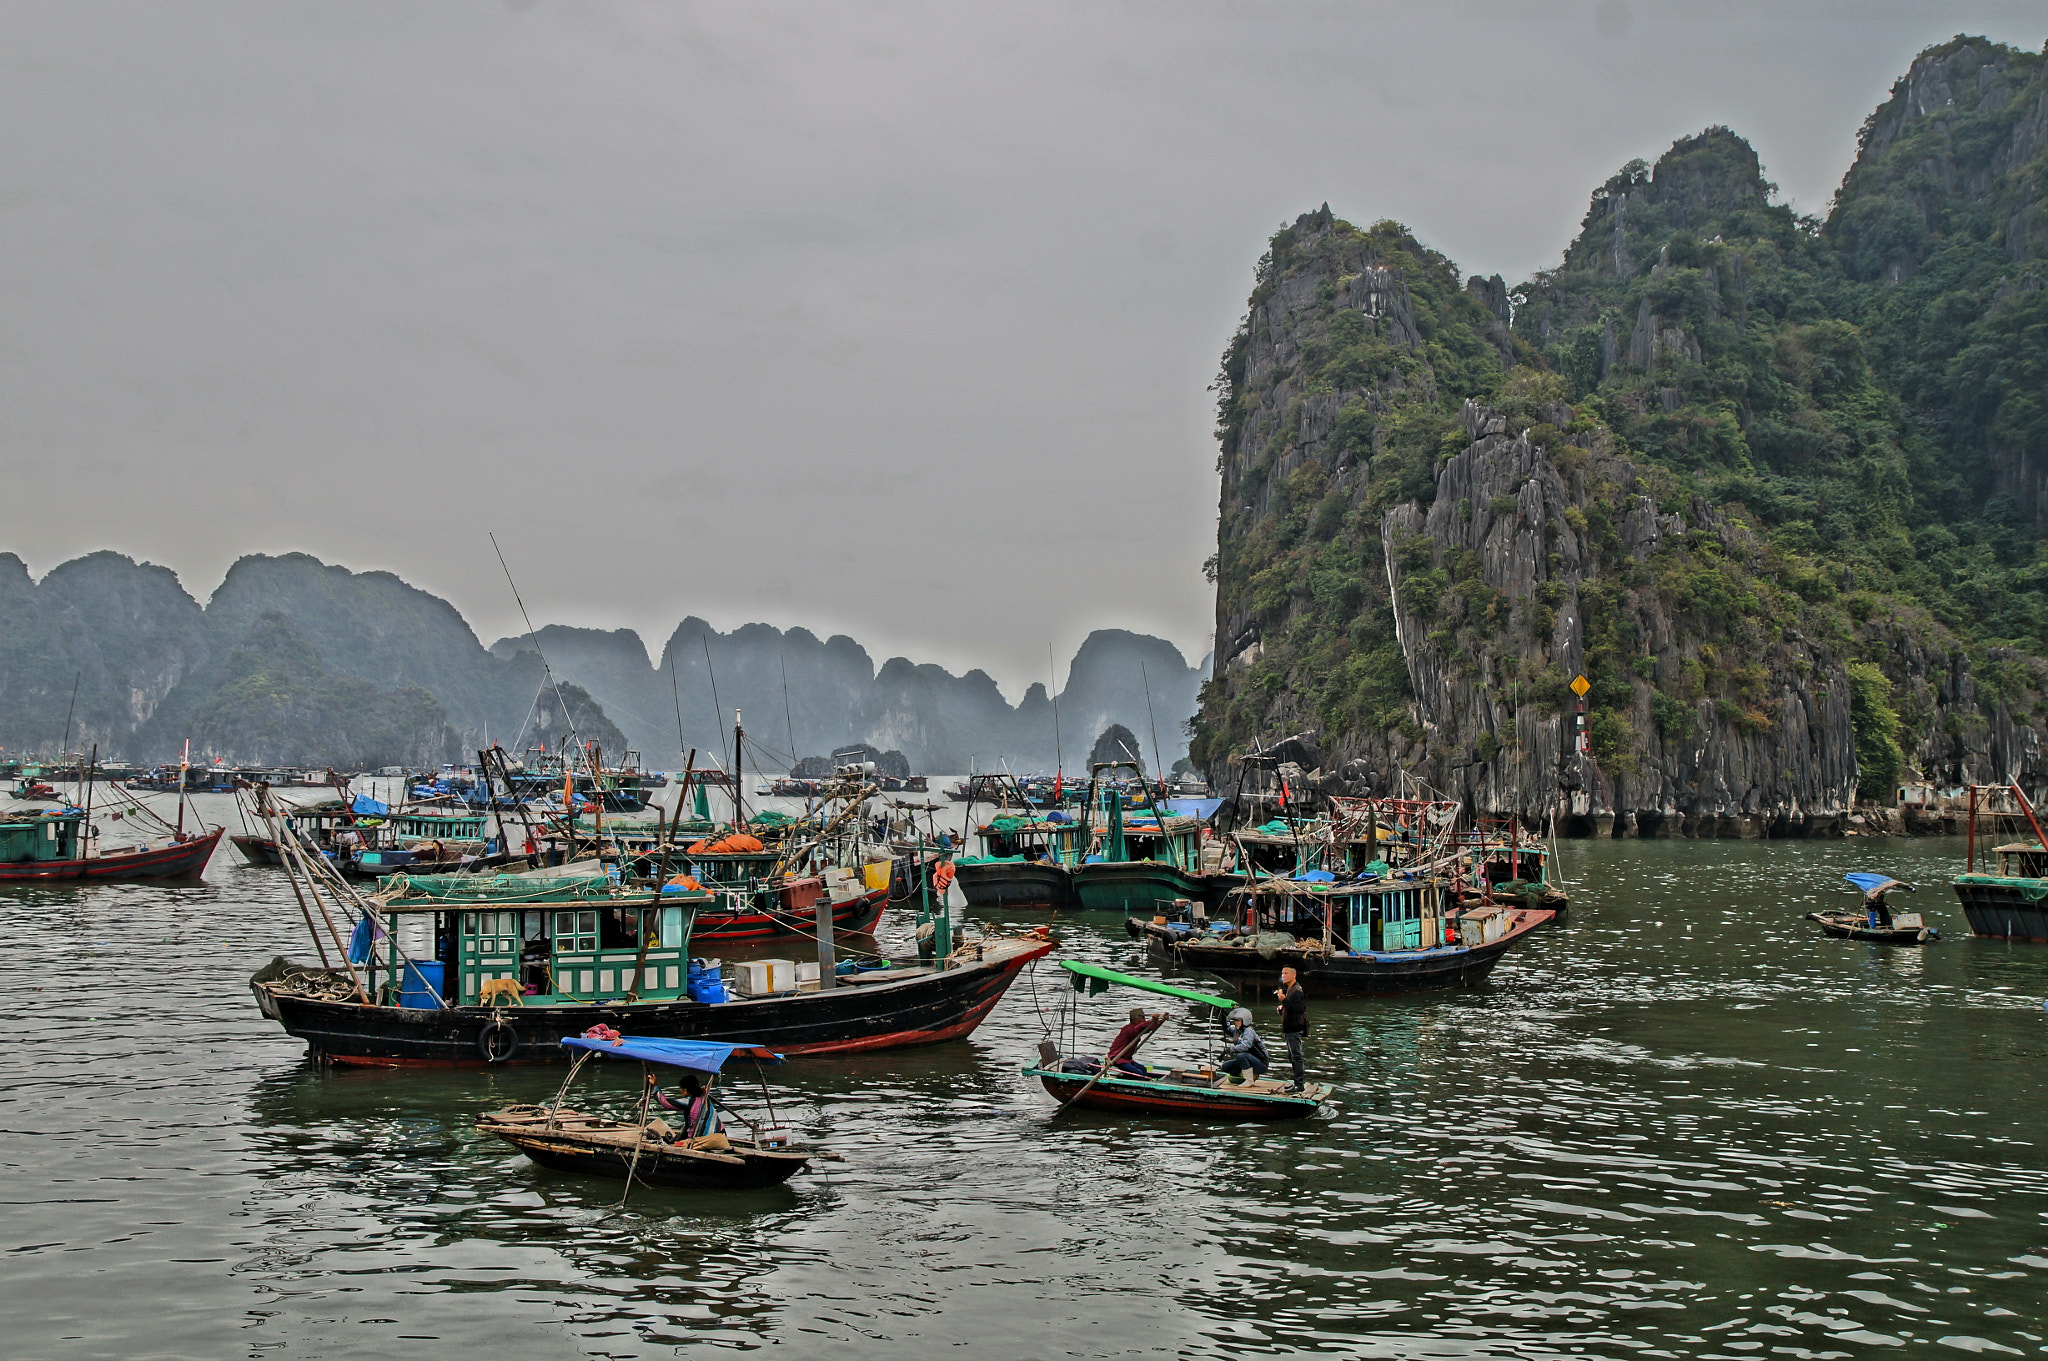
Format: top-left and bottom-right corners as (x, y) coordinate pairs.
(0, 0), (2048, 698)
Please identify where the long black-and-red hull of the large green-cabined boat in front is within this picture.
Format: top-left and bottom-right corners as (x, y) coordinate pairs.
(250, 937), (1053, 1068)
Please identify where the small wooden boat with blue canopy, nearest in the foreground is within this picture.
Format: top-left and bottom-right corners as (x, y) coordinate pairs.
(477, 1027), (834, 1195)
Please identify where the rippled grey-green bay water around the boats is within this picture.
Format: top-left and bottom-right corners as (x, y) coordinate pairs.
(0, 800), (2048, 1359)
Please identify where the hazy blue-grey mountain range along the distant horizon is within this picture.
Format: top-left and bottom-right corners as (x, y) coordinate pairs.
(0, 553), (1208, 772)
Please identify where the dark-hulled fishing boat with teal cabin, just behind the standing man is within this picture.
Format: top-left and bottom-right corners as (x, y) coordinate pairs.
(1167, 874), (1554, 997)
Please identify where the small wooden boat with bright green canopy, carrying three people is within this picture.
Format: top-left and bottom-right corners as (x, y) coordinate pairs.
(1024, 960), (1333, 1119)
